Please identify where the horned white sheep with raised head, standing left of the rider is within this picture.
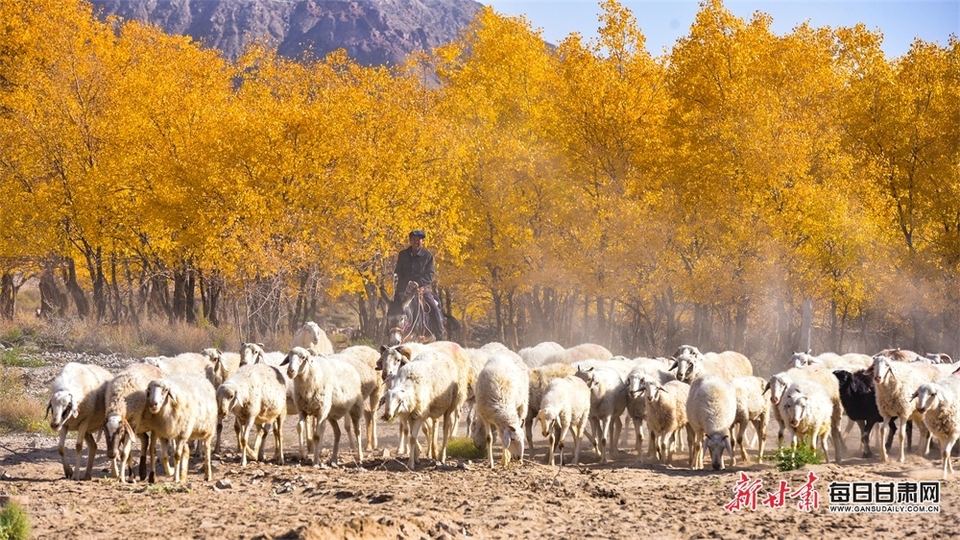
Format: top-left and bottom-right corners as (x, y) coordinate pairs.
(283, 347), (363, 466)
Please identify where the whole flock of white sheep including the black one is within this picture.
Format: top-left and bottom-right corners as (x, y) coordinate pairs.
(48, 323), (960, 482)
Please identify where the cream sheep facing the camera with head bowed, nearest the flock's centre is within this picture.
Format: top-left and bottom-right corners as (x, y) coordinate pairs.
(528, 375), (590, 465)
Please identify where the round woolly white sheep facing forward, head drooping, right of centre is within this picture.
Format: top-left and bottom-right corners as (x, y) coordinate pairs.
(687, 375), (737, 471)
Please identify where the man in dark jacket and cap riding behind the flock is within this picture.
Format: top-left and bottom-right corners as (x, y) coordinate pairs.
(393, 229), (447, 341)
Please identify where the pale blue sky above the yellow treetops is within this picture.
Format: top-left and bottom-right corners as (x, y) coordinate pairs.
(480, 0), (960, 58)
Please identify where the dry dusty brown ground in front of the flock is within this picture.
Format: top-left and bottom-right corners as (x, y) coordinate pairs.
(0, 352), (960, 539)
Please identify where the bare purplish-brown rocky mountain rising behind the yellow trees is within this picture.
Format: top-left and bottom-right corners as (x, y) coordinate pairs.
(92, 0), (481, 65)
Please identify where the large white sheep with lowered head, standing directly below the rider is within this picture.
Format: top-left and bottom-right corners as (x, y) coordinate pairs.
(382, 350), (460, 469)
